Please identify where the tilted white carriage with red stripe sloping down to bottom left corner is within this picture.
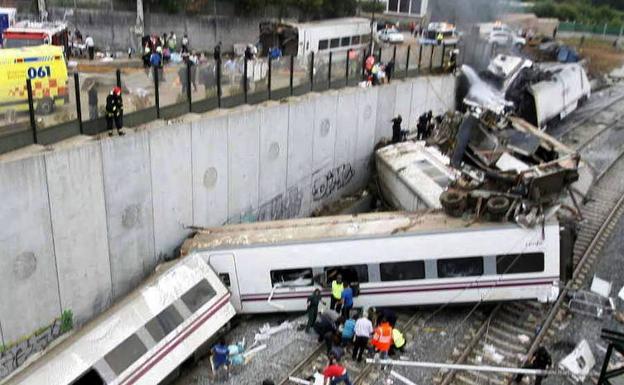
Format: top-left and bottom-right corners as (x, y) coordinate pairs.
(7, 256), (235, 385)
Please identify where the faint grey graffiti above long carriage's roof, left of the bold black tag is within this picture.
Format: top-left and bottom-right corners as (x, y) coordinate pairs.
(228, 186), (303, 223)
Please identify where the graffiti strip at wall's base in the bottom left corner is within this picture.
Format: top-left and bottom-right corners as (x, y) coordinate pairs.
(0, 310), (73, 381)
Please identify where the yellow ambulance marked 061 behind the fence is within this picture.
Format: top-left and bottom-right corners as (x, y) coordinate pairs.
(0, 45), (69, 115)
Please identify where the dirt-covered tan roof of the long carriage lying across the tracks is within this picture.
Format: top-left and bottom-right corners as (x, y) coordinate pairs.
(181, 210), (556, 255)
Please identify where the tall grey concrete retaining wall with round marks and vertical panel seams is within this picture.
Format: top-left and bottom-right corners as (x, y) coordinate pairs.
(0, 77), (455, 344)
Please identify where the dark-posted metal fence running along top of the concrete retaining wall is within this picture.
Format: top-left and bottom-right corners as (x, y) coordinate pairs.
(0, 45), (461, 153)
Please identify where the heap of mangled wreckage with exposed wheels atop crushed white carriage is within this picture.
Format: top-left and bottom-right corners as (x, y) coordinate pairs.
(376, 56), (589, 227)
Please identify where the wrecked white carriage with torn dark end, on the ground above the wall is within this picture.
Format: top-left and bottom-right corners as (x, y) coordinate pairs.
(260, 17), (371, 57)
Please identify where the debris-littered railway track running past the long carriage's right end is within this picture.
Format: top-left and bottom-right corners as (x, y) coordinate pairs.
(434, 146), (624, 385)
